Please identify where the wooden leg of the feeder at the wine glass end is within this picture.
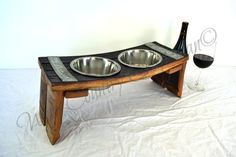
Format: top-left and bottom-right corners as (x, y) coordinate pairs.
(152, 63), (186, 97)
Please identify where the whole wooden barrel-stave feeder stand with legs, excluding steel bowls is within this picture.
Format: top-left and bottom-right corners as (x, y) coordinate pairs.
(38, 42), (188, 144)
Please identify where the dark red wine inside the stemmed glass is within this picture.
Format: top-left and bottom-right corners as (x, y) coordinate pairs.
(193, 54), (214, 68)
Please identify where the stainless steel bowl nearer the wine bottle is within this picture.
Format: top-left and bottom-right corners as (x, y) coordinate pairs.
(118, 49), (162, 68)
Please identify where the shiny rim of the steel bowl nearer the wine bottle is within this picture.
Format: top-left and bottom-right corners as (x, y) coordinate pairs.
(118, 49), (162, 69)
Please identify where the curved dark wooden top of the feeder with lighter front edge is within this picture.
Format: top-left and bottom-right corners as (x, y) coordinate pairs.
(38, 42), (188, 90)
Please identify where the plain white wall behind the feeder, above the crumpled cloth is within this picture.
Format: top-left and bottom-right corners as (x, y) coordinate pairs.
(0, 0), (236, 69)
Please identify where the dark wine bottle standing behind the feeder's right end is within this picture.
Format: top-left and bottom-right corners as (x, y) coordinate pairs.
(174, 22), (188, 54)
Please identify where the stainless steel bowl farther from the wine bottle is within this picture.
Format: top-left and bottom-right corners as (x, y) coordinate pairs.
(70, 57), (121, 77)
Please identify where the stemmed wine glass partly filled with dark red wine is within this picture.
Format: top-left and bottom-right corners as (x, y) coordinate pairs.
(188, 43), (216, 91)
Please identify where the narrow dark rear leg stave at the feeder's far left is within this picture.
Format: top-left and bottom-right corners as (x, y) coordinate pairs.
(39, 72), (47, 125)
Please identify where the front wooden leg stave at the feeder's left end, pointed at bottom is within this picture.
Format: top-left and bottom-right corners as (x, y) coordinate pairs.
(46, 86), (64, 144)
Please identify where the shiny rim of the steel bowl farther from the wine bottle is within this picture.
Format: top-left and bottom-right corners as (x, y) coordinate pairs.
(70, 56), (121, 77)
